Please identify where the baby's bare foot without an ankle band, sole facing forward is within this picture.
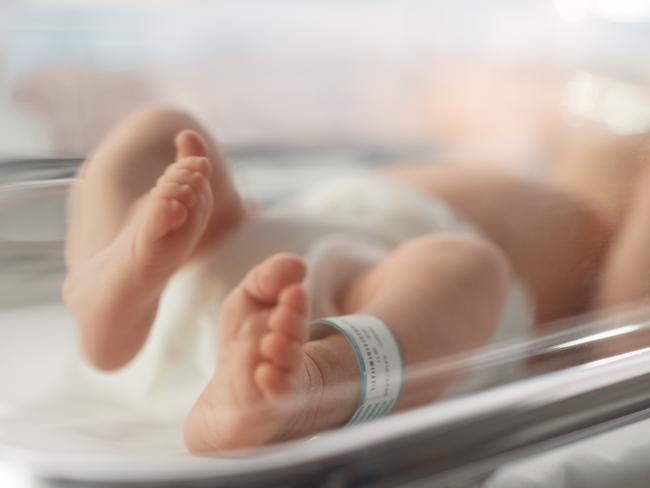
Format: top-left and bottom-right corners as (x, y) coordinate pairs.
(63, 151), (213, 370)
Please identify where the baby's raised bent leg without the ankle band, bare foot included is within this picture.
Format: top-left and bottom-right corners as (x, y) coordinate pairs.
(63, 110), (243, 369)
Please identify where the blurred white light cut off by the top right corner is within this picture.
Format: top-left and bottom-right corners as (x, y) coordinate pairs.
(554, 0), (650, 22)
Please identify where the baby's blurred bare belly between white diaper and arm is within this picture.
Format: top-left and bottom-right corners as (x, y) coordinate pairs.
(378, 165), (613, 324)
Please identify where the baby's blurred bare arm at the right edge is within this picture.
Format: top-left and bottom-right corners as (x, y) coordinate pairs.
(553, 134), (650, 358)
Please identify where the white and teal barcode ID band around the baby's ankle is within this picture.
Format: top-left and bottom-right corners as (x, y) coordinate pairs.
(312, 315), (404, 425)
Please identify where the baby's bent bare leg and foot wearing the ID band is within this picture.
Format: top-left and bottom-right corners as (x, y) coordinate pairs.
(185, 236), (509, 452)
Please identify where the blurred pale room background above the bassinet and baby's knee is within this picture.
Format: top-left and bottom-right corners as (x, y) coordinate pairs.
(0, 0), (650, 172)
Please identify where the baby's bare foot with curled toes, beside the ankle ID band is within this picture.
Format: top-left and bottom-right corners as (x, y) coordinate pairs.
(185, 254), (322, 452)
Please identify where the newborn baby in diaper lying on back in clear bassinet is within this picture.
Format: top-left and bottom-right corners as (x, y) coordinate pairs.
(63, 109), (644, 453)
